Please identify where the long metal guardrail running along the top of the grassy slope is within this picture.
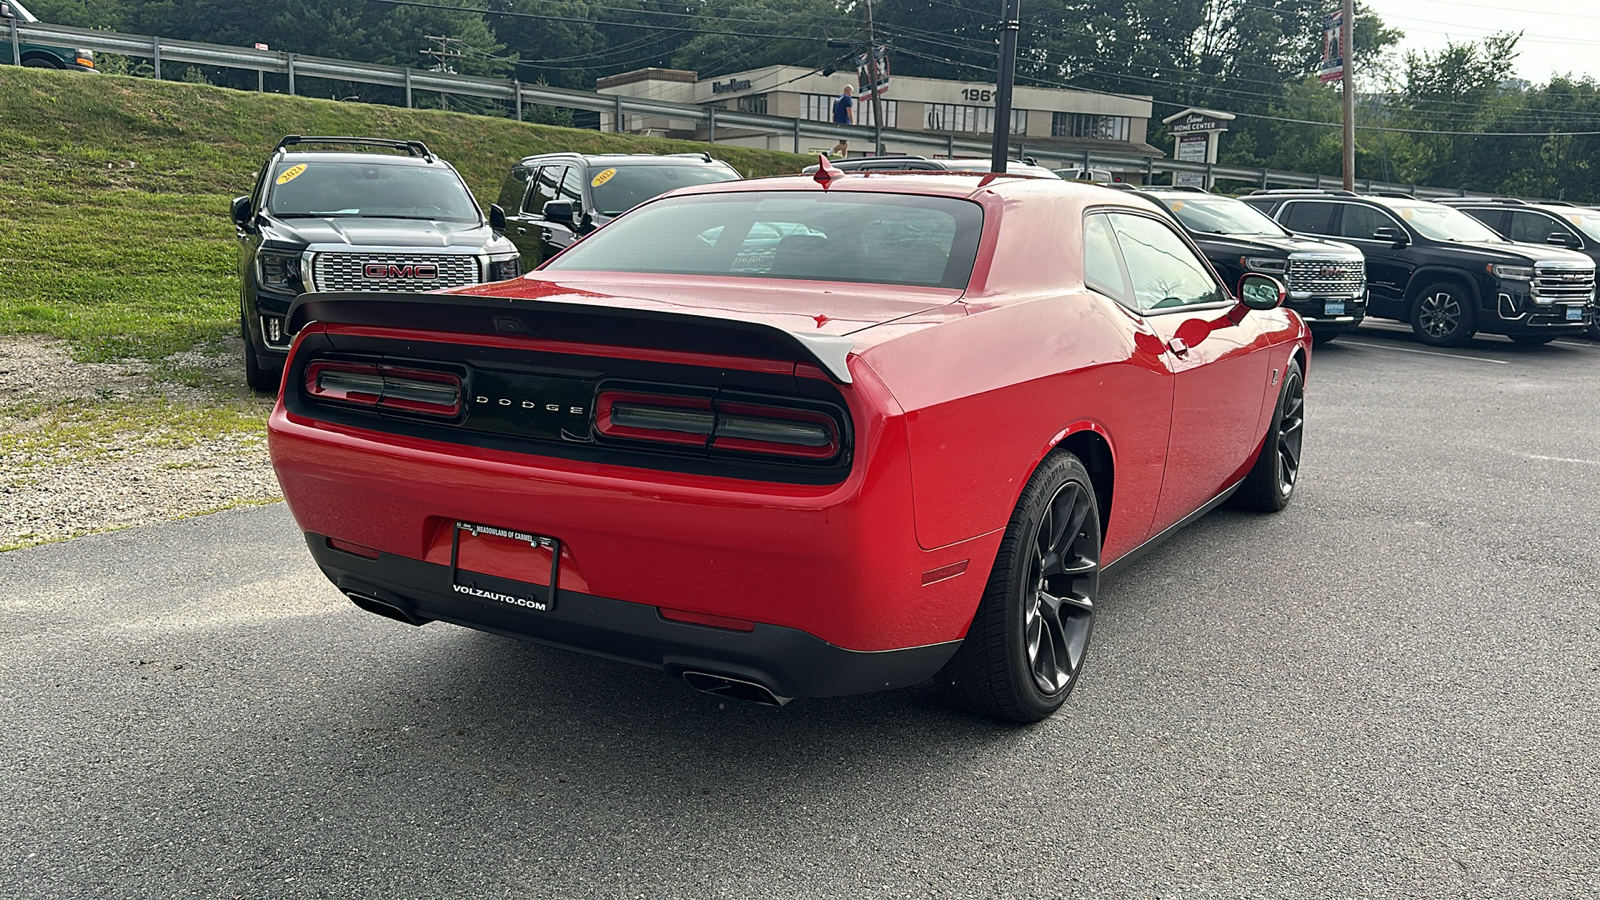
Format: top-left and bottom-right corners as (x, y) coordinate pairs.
(6, 19), (1467, 199)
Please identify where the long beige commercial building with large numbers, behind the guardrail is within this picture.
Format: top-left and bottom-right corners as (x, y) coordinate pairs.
(595, 66), (1166, 165)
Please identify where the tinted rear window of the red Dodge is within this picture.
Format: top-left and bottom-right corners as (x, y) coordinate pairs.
(544, 191), (984, 288)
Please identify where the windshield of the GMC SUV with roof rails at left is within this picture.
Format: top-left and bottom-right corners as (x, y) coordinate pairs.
(267, 160), (482, 224)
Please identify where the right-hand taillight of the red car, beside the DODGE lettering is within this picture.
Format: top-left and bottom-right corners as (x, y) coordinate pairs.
(595, 391), (840, 461)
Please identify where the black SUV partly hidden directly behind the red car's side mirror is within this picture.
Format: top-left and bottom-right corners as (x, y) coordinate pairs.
(1136, 187), (1366, 343)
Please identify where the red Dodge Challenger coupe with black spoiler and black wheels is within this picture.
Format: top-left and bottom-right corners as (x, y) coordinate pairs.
(270, 167), (1310, 722)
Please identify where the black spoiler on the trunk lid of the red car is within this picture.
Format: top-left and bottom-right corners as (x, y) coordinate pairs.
(288, 291), (856, 384)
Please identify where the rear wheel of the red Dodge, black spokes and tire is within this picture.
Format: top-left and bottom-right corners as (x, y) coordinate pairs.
(949, 453), (1101, 724)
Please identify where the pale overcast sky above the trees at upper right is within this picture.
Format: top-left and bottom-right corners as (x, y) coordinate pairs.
(1363, 0), (1600, 83)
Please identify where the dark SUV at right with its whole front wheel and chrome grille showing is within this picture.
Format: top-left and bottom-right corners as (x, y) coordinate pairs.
(1242, 191), (1595, 346)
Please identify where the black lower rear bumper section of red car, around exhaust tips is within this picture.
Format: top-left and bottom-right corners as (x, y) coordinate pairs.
(306, 533), (960, 697)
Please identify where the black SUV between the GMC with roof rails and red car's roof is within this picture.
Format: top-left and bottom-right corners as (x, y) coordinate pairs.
(499, 152), (739, 269)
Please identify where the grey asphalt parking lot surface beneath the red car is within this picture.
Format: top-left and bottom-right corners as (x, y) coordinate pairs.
(0, 327), (1600, 898)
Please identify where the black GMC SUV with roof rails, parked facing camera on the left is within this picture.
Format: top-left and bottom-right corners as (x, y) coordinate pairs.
(232, 135), (522, 391)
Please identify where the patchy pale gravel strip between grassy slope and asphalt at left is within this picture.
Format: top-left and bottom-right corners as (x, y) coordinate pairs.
(0, 336), (282, 548)
